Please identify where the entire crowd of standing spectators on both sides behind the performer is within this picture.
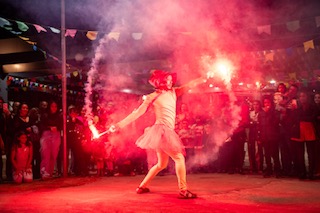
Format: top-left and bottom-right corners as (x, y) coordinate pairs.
(0, 83), (320, 183)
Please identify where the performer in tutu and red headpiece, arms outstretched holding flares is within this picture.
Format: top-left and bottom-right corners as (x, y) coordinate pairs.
(106, 70), (206, 199)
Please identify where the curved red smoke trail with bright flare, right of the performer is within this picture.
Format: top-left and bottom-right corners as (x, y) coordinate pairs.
(188, 55), (241, 168)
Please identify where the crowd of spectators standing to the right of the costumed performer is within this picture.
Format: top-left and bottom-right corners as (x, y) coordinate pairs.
(176, 83), (320, 180)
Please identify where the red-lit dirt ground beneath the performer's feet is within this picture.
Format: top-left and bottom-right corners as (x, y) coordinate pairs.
(0, 173), (320, 213)
